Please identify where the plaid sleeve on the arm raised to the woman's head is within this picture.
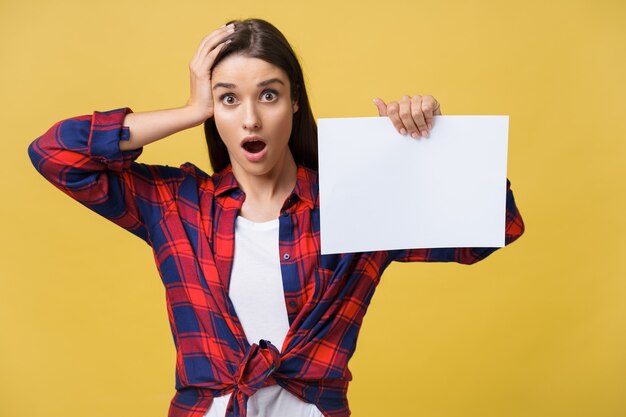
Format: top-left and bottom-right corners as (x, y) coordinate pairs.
(28, 108), (182, 243)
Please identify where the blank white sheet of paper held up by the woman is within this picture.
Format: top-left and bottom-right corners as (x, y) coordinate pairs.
(318, 116), (509, 254)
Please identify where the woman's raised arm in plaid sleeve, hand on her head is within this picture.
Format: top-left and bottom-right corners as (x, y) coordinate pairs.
(28, 23), (232, 243)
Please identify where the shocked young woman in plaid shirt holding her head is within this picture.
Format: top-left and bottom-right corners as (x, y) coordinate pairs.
(29, 19), (524, 417)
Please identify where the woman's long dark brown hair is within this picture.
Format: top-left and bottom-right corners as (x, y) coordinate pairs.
(204, 19), (317, 172)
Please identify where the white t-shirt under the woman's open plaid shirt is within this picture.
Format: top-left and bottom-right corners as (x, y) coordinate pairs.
(204, 216), (323, 417)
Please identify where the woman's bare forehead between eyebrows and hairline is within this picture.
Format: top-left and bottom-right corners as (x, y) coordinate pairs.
(211, 55), (289, 86)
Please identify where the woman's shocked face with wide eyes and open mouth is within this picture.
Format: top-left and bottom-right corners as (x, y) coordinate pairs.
(211, 55), (298, 176)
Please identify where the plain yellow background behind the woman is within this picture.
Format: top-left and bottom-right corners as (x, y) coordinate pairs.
(0, 0), (626, 417)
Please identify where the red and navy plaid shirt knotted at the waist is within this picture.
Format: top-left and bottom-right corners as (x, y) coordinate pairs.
(28, 108), (524, 417)
